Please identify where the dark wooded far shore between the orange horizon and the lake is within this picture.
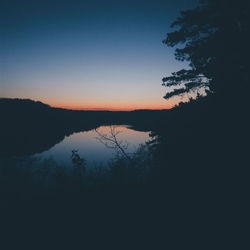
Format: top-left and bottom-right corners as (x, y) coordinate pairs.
(0, 98), (169, 156)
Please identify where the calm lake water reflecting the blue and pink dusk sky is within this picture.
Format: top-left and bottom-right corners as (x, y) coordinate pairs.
(35, 125), (150, 167)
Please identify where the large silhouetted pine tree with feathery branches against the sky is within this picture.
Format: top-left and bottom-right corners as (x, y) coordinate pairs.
(163, 0), (250, 101)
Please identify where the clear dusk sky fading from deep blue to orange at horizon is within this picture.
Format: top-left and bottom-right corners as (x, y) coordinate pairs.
(0, 0), (197, 110)
